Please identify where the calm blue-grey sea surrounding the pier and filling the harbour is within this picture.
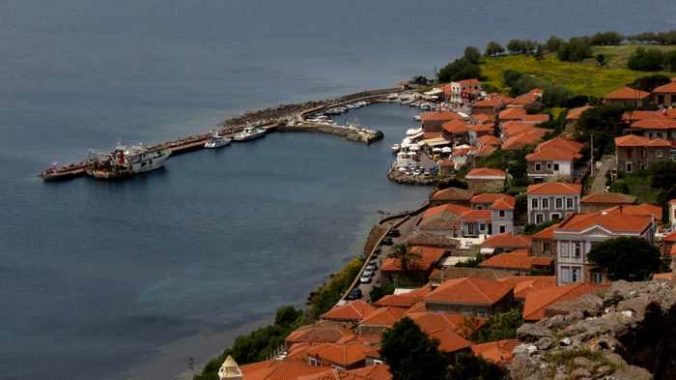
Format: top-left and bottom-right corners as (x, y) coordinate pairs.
(0, 0), (676, 380)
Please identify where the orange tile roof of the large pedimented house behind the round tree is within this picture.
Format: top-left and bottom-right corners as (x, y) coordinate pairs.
(554, 212), (653, 234)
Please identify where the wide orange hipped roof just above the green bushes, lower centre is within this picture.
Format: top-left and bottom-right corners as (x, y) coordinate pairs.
(425, 277), (512, 305)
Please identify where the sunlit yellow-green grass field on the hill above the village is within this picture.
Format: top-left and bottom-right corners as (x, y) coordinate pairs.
(481, 45), (676, 97)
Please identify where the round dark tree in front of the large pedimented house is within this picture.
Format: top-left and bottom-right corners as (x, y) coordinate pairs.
(587, 238), (662, 281)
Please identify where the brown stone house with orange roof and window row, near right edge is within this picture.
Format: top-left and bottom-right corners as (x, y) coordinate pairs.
(615, 135), (671, 173)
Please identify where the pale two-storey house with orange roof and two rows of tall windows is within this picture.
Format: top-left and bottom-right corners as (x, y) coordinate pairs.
(526, 182), (582, 224)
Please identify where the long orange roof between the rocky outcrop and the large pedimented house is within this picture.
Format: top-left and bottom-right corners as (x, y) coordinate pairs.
(523, 282), (607, 321)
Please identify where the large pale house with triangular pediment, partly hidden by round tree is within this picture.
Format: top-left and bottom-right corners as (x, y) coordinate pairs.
(554, 211), (655, 285)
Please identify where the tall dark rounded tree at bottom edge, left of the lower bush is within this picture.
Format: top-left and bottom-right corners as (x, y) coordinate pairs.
(380, 317), (448, 380)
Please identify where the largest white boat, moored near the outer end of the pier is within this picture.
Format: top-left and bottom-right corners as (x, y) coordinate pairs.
(86, 144), (171, 179)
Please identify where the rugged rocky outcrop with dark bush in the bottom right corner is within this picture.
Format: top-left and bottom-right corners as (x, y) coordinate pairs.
(509, 281), (676, 380)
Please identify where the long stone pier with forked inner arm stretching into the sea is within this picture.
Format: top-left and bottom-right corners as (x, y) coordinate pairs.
(39, 87), (403, 182)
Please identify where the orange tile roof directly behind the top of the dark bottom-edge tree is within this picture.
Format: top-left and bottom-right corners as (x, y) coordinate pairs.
(410, 312), (472, 353)
